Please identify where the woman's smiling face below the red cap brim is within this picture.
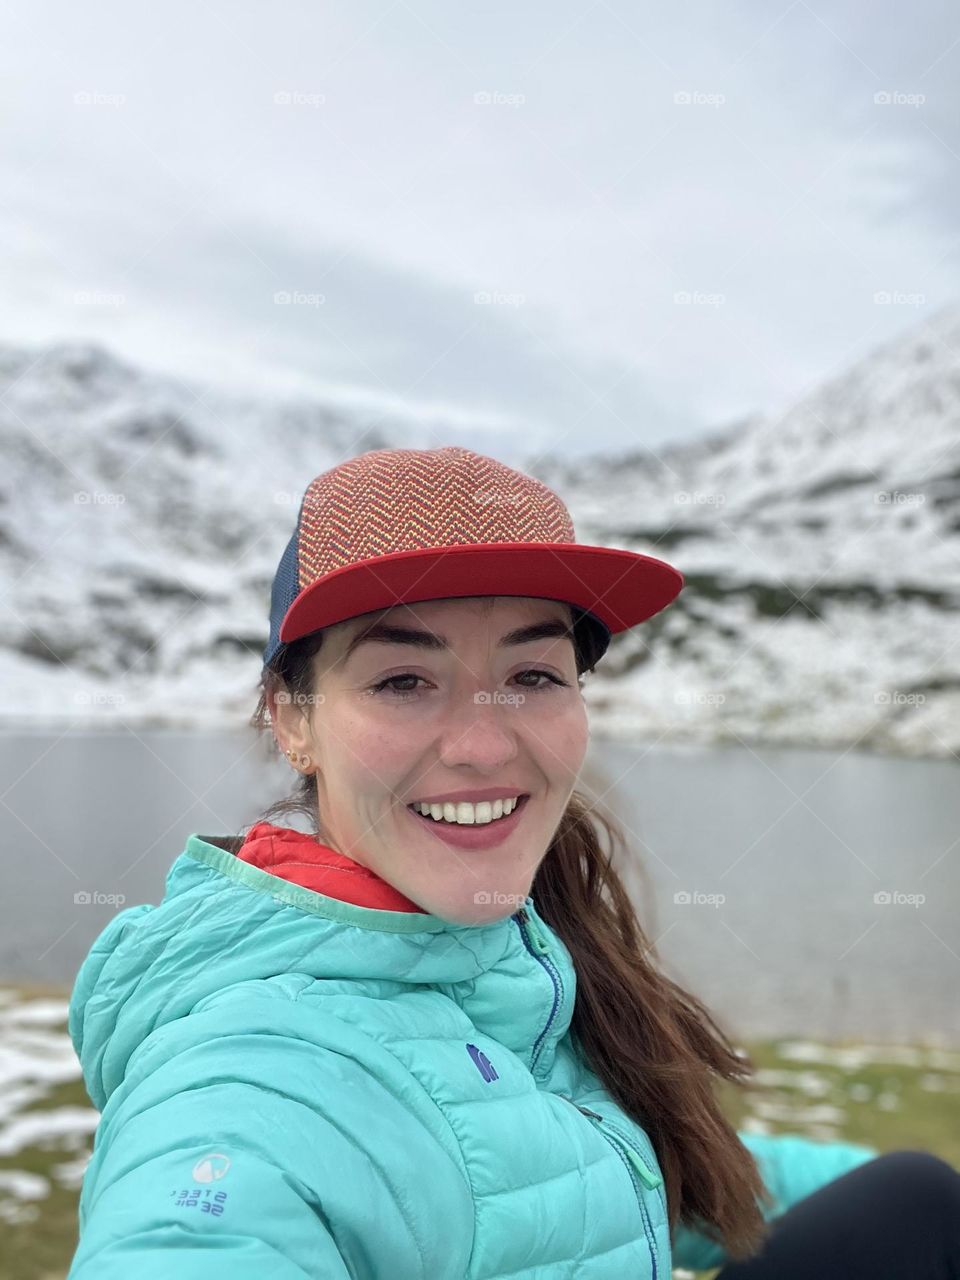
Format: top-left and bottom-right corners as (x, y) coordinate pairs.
(270, 596), (589, 924)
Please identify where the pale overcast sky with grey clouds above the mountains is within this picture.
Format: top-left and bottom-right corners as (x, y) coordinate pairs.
(0, 0), (960, 452)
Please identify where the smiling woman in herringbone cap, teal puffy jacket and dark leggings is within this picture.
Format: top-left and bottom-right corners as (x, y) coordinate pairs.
(70, 448), (960, 1280)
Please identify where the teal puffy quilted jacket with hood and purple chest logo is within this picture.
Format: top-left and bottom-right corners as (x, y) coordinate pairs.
(68, 835), (876, 1280)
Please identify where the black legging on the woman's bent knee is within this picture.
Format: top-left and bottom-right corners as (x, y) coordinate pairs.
(716, 1151), (960, 1280)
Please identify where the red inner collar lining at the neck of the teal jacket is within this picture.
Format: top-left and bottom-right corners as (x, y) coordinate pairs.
(237, 822), (424, 911)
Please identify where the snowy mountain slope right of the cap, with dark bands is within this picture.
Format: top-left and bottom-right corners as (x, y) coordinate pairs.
(529, 308), (960, 756)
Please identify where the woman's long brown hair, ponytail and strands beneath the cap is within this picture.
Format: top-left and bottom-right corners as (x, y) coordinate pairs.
(250, 609), (771, 1260)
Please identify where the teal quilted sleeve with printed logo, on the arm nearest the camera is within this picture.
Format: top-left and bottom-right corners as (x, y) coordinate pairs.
(68, 980), (474, 1280)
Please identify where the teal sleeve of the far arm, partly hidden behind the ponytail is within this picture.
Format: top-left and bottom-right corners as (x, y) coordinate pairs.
(673, 1130), (879, 1271)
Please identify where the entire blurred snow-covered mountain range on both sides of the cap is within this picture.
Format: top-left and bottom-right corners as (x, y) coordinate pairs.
(0, 310), (960, 755)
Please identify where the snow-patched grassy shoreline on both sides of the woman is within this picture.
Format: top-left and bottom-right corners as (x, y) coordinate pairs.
(0, 983), (960, 1280)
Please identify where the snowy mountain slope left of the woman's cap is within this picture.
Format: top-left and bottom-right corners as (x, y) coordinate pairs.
(0, 343), (401, 724)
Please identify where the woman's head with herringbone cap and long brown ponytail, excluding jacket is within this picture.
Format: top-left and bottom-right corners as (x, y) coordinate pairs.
(241, 448), (783, 1268)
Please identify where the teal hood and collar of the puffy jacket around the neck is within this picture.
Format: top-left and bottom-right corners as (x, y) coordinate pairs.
(68, 835), (576, 1111)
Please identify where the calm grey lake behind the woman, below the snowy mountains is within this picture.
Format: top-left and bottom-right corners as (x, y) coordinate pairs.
(0, 728), (960, 1044)
